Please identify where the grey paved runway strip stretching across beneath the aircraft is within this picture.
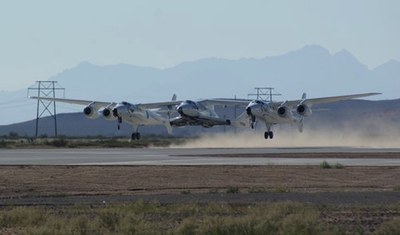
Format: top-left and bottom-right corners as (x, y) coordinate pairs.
(0, 147), (400, 166)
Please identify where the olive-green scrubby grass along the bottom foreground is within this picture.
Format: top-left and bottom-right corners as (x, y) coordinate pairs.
(0, 202), (400, 235)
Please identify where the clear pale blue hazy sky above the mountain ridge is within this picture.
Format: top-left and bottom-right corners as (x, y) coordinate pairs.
(0, 0), (400, 90)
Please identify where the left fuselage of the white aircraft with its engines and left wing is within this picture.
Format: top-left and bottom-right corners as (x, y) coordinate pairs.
(30, 95), (182, 140)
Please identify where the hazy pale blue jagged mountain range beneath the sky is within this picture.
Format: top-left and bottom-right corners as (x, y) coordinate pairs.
(0, 45), (400, 124)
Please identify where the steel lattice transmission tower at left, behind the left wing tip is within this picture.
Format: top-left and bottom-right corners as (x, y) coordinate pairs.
(28, 81), (65, 138)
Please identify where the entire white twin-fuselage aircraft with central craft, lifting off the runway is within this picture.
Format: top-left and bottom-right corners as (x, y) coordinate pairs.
(31, 93), (380, 139)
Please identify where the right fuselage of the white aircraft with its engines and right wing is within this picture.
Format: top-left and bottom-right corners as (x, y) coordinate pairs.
(214, 93), (381, 139)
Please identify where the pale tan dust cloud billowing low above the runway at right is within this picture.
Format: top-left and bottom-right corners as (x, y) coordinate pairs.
(172, 128), (400, 148)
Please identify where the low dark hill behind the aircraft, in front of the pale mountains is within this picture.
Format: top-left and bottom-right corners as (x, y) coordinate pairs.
(0, 99), (400, 137)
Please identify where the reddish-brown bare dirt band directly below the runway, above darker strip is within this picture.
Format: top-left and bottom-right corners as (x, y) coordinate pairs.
(0, 166), (400, 198)
